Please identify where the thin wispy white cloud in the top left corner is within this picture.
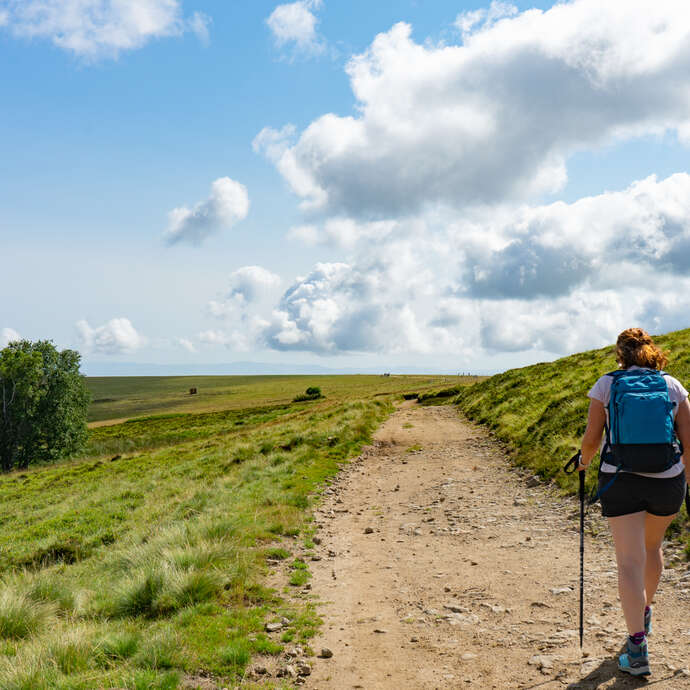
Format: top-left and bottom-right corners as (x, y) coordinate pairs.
(0, 0), (210, 59)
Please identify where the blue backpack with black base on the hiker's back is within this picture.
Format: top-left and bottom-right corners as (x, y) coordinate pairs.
(602, 369), (681, 474)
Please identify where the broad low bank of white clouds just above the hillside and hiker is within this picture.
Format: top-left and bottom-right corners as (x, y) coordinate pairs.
(212, 173), (690, 362)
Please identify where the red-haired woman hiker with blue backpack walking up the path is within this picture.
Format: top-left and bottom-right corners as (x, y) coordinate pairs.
(578, 328), (690, 676)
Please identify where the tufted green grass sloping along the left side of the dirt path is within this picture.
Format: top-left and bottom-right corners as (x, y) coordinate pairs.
(0, 382), (392, 690)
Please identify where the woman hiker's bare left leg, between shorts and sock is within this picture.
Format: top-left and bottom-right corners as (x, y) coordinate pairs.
(608, 511), (644, 635)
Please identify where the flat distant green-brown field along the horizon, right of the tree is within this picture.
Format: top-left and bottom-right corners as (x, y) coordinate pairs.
(86, 375), (474, 423)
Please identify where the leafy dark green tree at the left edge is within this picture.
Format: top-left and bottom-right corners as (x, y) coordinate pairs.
(0, 340), (91, 472)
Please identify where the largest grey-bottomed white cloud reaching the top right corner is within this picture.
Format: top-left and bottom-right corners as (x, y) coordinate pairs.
(255, 0), (690, 218)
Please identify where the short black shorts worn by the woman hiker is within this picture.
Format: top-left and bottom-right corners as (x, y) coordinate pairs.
(599, 472), (685, 517)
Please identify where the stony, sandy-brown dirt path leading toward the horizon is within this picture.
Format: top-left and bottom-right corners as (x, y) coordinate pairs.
(306, 407), (690, 690)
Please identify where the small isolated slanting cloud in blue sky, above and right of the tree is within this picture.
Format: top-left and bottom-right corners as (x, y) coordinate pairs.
(165, 177), (249, 246)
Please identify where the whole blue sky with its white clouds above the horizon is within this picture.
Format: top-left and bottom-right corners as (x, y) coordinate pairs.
(0, 0), (690, 371)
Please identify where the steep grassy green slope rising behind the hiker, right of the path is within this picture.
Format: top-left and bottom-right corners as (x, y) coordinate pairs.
(455, 329), (690, 548)
